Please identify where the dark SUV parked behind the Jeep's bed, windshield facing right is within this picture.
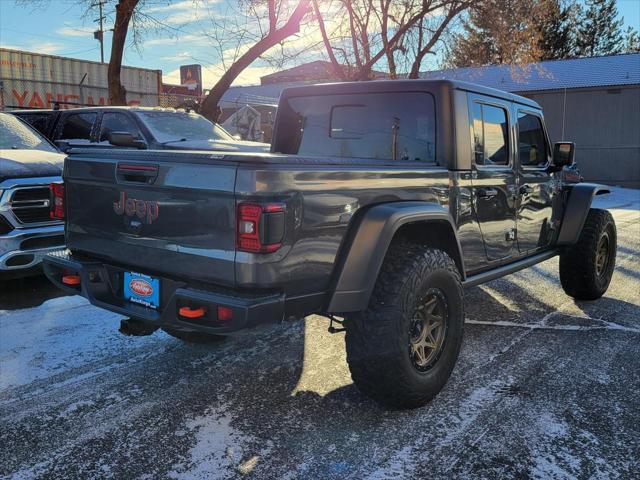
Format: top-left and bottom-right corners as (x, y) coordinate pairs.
(11, 107), (269, 152)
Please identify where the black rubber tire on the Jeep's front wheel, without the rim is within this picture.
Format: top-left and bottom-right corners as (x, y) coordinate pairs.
(560, 208), (617, 300)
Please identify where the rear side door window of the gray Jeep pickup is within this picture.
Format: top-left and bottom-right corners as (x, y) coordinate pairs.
(473, 103), (509, 165)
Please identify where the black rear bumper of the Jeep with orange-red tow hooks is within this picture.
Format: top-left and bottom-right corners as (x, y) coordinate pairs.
(43, 250), (284, 334)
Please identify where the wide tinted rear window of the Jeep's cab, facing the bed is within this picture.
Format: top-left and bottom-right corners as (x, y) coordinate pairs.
(275, 93), (436, 162)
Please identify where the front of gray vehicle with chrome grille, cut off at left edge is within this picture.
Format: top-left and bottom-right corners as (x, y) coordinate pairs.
(0, 113), (64, 279)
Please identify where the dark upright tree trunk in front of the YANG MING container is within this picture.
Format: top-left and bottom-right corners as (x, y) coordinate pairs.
(107, 0), (139, 105)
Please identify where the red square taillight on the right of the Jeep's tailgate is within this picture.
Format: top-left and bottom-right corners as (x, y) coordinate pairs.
(236, 203), (285, 253)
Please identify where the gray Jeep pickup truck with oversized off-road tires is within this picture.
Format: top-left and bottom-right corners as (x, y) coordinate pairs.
(45, 80), (616, 408)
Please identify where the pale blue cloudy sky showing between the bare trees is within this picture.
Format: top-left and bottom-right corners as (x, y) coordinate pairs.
(0, 0), (640, 88)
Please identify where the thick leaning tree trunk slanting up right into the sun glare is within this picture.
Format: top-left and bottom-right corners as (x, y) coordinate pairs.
(200, 0), (311, 122)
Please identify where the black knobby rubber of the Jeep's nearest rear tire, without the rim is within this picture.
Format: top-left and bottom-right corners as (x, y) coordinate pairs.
(346, 243), (464, 409)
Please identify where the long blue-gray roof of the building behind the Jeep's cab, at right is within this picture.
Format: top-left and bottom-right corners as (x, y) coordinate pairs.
(420, 53), (640, 92)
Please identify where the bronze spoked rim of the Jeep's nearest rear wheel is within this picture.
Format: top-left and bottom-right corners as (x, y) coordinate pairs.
(409, 289), (447, 372)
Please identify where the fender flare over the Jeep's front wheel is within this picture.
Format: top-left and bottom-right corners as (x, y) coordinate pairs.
(556, 183), (611, 246)
